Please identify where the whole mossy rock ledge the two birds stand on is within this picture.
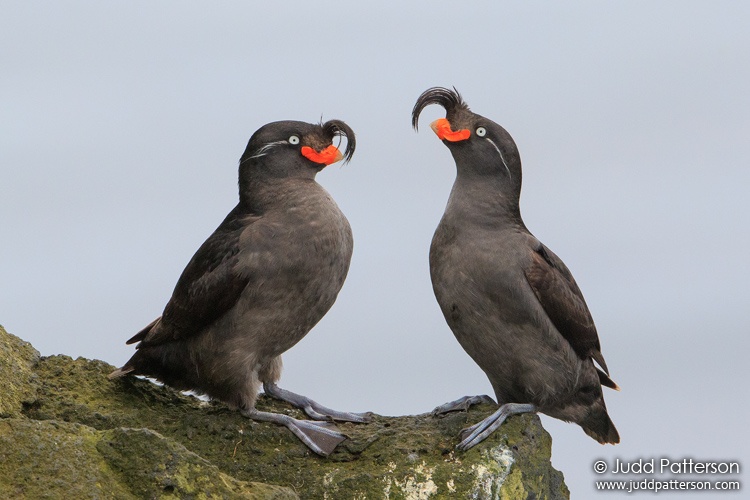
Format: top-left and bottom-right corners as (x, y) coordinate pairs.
(0, 327), (569, 499)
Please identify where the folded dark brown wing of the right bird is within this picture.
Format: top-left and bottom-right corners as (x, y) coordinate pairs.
(524, 243), (614, 376)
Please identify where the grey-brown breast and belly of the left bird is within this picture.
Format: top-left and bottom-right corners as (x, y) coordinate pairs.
(227, 191), (353, 359)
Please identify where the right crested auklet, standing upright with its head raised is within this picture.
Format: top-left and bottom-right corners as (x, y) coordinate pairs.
(412, 87), (620, 451)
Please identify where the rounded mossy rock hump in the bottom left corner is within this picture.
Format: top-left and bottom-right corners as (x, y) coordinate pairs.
(0, 418), (297, 500)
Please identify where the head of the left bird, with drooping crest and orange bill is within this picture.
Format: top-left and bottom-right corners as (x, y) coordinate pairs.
(240, 120), (356, 178)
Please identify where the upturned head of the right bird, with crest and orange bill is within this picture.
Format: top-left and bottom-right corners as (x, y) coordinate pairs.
(411, 87), (521, 192)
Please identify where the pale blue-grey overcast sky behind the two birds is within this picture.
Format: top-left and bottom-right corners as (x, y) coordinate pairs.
(0, 1), (750, 498)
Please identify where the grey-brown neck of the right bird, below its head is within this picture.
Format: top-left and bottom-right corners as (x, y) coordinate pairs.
(446, 173), (524, 226)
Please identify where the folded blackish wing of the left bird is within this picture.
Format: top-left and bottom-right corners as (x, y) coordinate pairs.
(127, 209), (259, 347)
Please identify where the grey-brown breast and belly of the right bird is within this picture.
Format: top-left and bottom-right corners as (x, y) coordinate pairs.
(430, 219), (577, 403)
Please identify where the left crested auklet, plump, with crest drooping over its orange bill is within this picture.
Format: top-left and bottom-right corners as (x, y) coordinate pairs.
(109, 120), (369, 456)
